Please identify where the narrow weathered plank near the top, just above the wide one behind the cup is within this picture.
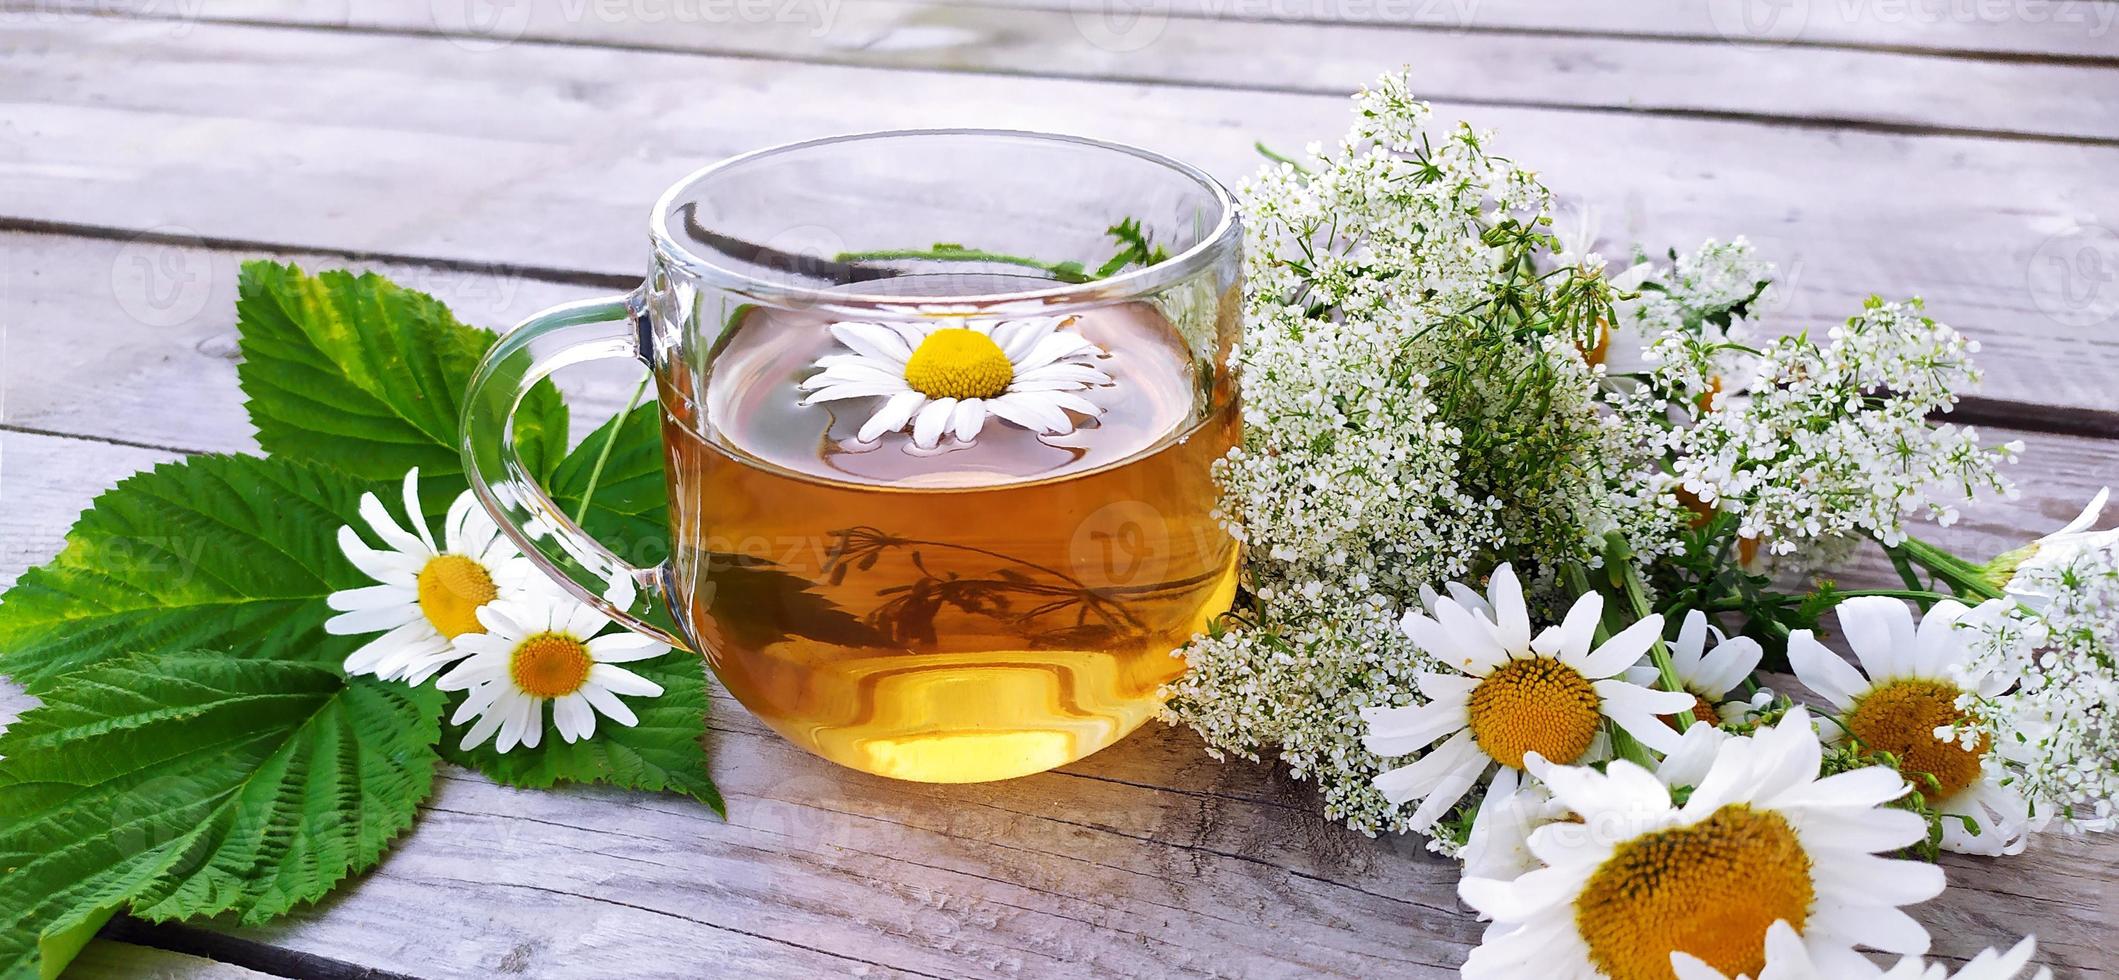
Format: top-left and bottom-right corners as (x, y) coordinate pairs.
(45, 0), (2119, 142)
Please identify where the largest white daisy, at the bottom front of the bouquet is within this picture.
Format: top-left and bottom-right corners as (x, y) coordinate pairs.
(1458, 708), (1943, 980)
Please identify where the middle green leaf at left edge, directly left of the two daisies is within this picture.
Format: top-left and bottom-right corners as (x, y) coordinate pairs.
(0, 456), (369, 696)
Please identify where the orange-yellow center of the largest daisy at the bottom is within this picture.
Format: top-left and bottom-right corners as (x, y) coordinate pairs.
(1574, 804), (1816, 980)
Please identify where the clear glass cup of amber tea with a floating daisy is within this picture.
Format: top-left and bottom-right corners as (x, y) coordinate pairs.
(462, 129), (1242, 783)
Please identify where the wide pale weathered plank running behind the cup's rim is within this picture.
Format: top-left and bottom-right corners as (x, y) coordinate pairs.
(0, 19), (2119, 428)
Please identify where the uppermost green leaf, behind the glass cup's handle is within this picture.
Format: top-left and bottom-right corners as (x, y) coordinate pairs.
(235, 261), (566, 505)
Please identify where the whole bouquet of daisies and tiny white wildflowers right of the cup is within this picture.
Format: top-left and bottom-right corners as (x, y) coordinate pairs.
(1168, 76), (2119, 976)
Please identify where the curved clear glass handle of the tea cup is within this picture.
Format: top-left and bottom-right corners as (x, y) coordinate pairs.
(458, 293), (691, 649)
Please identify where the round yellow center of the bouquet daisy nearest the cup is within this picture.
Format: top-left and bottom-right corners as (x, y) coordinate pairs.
(1468, 658), (1602, 768)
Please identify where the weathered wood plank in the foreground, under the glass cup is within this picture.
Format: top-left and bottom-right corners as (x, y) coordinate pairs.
(0, 433), (2119, 976)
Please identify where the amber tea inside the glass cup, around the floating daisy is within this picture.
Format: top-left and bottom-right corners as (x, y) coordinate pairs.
(663, 296), (1237, 783)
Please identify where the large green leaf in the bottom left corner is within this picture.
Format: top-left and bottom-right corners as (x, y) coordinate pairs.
(0, 651), (441, 976)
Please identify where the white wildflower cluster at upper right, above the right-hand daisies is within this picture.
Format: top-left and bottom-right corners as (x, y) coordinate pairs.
(1666, 299), (2022, 554)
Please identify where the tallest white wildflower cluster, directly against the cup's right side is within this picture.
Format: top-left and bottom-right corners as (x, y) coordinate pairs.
(1168, 76), (1632, 832)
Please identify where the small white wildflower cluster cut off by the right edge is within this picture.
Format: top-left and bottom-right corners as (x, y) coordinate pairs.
(1958, 532), (2119, 832)
